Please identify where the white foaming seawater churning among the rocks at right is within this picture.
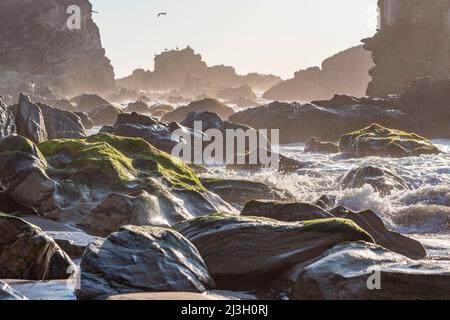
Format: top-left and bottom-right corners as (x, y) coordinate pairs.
(200, 140), (450, 239)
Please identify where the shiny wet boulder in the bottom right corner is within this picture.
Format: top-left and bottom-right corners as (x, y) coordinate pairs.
(289, 242), (450, 300)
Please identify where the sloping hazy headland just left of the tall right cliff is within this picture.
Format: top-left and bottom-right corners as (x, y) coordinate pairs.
(263, 46), (373, 101)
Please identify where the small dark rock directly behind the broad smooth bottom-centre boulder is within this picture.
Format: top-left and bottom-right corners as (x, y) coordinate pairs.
(241, 200), (333, 222)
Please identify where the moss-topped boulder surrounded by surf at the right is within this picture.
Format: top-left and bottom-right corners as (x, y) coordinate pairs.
(339, 123), (440, 158)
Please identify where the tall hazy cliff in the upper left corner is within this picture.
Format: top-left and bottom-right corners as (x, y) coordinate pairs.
(0, 0), (115, 96)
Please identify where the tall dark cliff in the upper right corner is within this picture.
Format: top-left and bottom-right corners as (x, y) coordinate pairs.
(363, 0), (450, 97)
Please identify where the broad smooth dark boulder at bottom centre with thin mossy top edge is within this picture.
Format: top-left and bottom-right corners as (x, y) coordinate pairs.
(174, 215), (373, 289)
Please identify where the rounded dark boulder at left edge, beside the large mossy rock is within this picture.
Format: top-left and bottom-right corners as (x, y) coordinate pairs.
(0, 136), (56, 214)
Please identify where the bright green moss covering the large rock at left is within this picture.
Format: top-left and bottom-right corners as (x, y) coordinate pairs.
(39, 133), (203, 190)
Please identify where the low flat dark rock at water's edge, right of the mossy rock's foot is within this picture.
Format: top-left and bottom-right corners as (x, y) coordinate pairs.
(200, 178), (294, 206)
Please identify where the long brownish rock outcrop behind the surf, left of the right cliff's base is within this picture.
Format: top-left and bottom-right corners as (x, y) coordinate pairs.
(229, 99), (419, 144)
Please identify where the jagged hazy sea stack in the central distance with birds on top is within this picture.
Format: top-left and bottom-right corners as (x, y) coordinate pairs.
(117, 47), (281, 94)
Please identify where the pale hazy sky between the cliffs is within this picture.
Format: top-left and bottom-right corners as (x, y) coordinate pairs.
(91, 0), (377, 78)
